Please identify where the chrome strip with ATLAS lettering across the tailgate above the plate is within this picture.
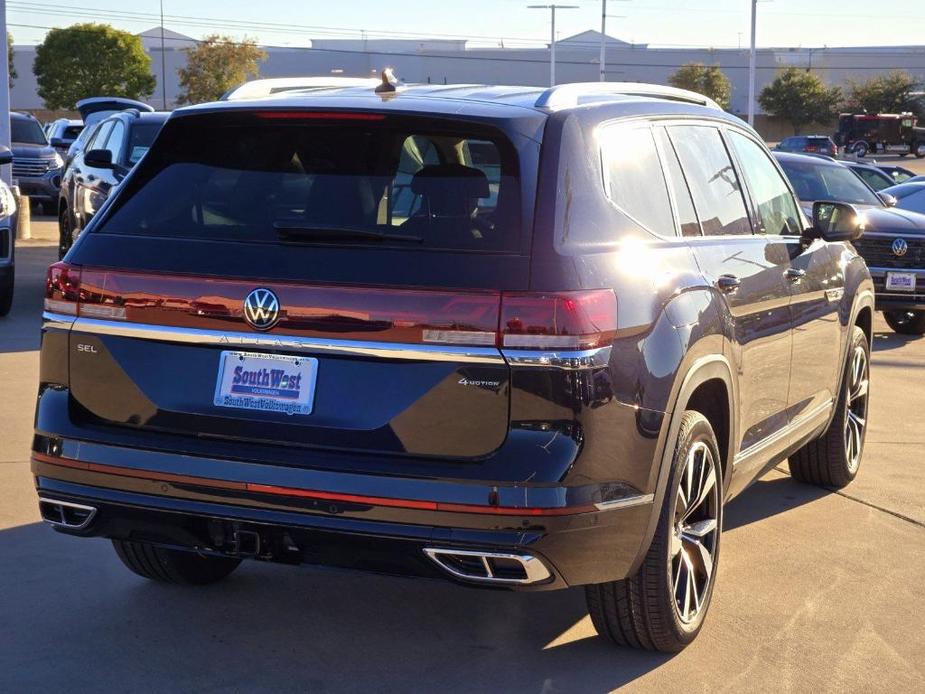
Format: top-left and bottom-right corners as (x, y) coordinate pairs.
(67, 317), (504, 364)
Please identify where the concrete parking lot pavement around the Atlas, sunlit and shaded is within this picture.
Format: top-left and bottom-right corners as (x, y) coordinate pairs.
(0, 220), (925, 693)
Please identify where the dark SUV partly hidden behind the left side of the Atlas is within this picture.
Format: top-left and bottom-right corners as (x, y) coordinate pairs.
(58, 109), (170, 258)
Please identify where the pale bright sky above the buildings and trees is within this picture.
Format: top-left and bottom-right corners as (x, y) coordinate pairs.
(6, 0), (925, 50)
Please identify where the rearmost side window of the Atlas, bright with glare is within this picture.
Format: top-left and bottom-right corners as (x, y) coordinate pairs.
(600, 123), (675, 236)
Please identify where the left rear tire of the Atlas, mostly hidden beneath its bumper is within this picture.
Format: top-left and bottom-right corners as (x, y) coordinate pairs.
(112, 540), (241, 586)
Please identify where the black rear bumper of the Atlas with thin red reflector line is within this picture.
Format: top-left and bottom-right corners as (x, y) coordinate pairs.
(32, 444), (652, 590)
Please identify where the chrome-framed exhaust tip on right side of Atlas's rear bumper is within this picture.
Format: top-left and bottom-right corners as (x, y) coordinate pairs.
(424, 547), (552, 585)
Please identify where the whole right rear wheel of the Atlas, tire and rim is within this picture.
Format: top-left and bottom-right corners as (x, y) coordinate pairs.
(585, 410), (723, 653)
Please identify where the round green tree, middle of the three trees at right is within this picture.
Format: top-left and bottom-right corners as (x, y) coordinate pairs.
(758, 67), (842, 134)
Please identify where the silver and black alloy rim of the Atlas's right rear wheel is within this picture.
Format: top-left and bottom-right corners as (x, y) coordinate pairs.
(669, 441), (720, 624)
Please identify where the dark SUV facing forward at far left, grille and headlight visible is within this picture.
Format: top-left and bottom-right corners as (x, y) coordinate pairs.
(10, 113), (64, 207)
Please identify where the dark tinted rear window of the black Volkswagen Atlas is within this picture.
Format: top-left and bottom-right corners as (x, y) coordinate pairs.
(98, 113), (520, 251)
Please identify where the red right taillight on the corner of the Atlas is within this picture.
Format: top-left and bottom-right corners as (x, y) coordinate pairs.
(500, 289), (617, 350)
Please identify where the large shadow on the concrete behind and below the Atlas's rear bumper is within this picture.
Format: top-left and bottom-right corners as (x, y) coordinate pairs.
(0, 524), (669, 692)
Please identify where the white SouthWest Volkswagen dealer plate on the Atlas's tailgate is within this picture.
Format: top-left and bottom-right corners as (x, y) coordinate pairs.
(214, 351), (318, 414)
